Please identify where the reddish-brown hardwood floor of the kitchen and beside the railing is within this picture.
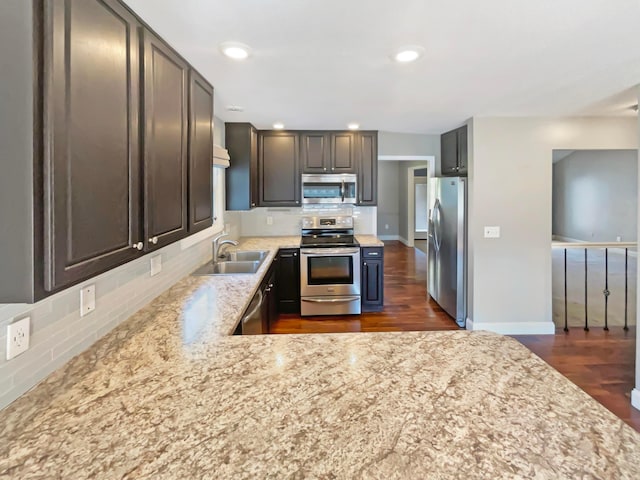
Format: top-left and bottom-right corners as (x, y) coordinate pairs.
(270, 242), (640, 431)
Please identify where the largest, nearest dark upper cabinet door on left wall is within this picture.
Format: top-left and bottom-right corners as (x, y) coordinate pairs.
(43, 0), (141, 291)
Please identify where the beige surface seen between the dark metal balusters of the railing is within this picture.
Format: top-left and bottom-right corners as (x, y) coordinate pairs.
(553, 243), (637, 327)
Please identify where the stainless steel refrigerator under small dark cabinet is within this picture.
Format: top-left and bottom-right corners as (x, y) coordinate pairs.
(427, 177), (467, 327)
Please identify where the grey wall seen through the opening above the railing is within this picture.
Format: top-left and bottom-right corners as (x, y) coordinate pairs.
(553, 150), (638, 242)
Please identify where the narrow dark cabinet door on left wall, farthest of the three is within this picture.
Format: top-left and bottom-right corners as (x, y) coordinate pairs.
(189, 70), (213, 233)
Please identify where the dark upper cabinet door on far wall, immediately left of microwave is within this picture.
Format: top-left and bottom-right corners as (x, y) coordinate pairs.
(258, 131), (300, 207)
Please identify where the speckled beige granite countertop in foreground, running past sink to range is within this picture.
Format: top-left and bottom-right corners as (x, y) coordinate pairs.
(0, 237), (640, 479)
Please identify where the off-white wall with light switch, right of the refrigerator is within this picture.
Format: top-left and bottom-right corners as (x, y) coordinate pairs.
(469, 117), (638, 333)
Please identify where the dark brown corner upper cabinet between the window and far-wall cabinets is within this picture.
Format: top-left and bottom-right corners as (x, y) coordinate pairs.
(225, 122), (259, 210)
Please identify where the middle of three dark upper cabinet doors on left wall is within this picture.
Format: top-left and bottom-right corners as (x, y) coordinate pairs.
(144, 30), (189, 249)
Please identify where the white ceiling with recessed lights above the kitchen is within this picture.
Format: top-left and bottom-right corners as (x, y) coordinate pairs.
(125, 0), (640, 133)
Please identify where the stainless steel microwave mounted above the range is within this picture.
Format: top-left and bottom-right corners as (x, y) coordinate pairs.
(302, 173), (358, 204)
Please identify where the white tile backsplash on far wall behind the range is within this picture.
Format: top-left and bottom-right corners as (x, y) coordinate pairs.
(225, 206), (377, 238)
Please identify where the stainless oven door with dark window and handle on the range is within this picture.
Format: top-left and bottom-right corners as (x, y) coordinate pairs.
(300, 248), (360, 297)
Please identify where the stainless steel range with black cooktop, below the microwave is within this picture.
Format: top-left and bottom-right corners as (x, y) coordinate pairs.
(300, 216), (360, 316)
